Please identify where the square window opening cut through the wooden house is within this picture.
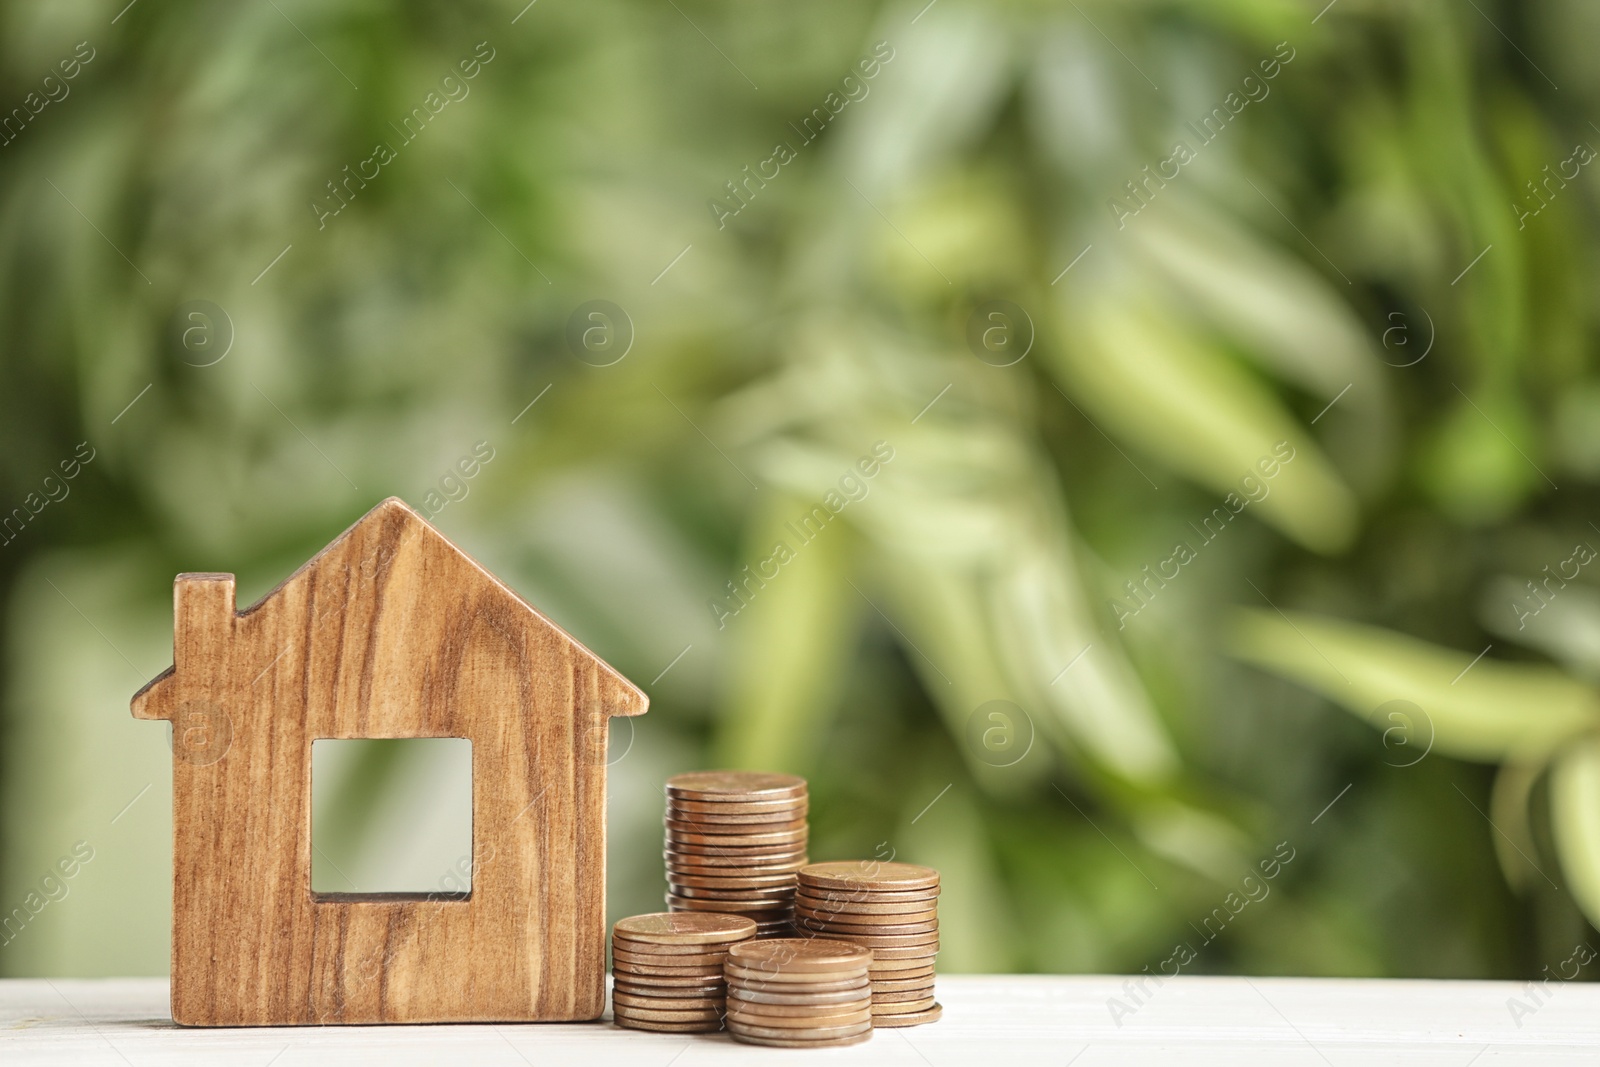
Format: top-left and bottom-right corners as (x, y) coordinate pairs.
(310, 737), (472, 899)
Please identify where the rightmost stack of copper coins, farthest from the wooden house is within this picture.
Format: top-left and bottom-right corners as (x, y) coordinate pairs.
(795, 861), (942, 1027)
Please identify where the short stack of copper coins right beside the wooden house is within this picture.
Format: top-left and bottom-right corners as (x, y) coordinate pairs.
(611, 912), (755, 1032)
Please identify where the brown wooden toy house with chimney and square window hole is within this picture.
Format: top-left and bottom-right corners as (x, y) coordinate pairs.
(133, 498), (648, 1025)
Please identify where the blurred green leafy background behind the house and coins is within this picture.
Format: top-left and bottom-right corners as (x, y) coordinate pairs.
(0, 0), (1600, 977)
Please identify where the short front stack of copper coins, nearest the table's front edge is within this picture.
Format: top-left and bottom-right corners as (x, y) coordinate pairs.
(723, 937), (874, 1048)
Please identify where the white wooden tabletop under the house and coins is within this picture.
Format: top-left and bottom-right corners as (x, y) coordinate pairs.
(0, 976), (1600, 1067)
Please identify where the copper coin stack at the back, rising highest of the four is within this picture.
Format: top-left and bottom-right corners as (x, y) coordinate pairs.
(666, 771), (806, 937)
